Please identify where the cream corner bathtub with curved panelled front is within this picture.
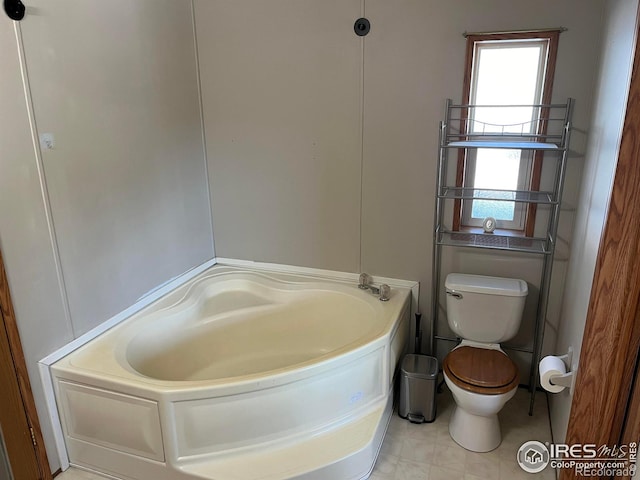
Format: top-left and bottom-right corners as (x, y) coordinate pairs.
(52, 267), (411, 480)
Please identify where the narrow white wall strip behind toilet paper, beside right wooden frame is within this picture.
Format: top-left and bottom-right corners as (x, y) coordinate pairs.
(550, 0), (638, 442)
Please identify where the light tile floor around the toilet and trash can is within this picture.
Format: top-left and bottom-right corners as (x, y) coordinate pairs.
(56, 387), (555, 480)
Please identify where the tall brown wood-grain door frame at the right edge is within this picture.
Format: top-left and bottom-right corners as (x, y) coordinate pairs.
(560, 9), (640, 479)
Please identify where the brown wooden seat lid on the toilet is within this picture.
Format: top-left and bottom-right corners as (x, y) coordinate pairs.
(442, 346), (518, 395)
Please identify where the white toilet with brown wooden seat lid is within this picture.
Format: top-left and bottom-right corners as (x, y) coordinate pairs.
(442, 273), (528, 452)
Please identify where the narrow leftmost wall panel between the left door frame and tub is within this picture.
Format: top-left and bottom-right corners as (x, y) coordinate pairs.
(0, 15), (73, 470)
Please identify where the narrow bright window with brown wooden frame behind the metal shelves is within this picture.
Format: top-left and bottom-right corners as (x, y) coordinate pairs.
(454, 31), (559, 236)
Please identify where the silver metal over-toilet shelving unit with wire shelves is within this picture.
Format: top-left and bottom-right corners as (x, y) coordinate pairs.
(430, 98), (573, 415)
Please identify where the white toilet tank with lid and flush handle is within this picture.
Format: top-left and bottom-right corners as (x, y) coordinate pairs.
(444, 273), (528, 343)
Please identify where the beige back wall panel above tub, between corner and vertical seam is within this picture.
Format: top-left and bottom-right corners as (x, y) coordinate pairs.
(195, 0), (362, 272)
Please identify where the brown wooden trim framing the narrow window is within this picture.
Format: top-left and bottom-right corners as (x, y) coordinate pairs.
(452, 29), (562, 237)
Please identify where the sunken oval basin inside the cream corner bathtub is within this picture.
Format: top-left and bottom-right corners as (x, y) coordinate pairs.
(126, 280), (384, 381)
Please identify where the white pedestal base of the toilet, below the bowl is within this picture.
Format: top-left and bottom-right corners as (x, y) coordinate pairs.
(449, 405), (502, 452)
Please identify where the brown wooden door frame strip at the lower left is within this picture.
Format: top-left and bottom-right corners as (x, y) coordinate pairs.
(0, 250), (52, 480)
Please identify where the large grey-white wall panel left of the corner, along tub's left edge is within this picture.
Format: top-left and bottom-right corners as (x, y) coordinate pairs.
(21, 0), (213, 335)
